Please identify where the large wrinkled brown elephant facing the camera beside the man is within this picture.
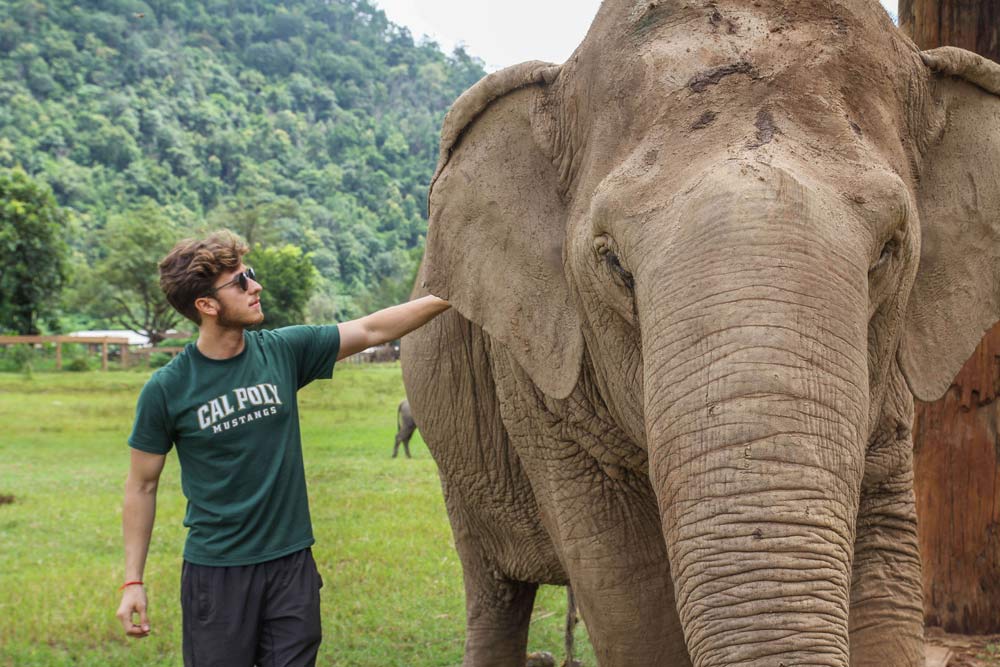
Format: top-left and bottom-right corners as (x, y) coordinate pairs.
(403, 0), (1000, 667)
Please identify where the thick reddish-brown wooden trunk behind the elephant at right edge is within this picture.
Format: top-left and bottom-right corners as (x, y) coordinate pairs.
(899, 0), (1000, 634)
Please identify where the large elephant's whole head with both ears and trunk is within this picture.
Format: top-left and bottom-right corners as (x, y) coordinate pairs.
(423, 0), (1000, 665)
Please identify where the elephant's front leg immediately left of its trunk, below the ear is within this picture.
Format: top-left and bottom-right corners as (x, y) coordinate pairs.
(494, 358), (691, 667)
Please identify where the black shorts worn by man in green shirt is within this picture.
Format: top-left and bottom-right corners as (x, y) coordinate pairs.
(181, 549), (323, 667)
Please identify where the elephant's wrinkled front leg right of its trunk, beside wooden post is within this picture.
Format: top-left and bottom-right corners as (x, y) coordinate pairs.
(850, 471), (924, 667)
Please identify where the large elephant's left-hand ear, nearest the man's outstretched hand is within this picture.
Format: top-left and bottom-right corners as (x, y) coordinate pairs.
(423, 61), (583, 398)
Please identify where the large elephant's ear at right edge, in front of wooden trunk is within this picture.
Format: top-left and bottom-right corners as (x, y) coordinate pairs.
(899, 47), (1000, 401)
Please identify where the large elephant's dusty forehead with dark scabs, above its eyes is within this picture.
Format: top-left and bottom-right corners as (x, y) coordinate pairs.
(563, 0), (922, 205)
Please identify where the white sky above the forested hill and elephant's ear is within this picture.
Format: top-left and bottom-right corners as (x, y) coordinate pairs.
(373, 0), (896, 71)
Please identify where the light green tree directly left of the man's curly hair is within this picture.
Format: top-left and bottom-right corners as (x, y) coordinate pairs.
(90, 204), (181, 345)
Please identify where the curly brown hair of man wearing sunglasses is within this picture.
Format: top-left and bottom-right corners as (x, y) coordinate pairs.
(160, 229), (250, 324)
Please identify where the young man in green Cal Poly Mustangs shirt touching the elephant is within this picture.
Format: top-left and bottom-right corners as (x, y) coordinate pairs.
(112, 232), (449, 667)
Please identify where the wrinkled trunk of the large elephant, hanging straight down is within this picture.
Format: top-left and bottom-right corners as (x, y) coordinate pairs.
(636, 166), (868, 667)
